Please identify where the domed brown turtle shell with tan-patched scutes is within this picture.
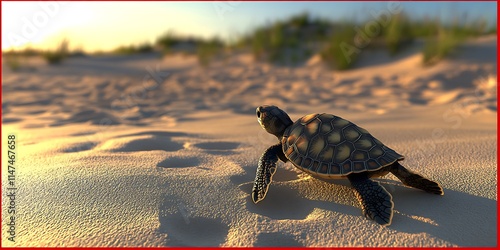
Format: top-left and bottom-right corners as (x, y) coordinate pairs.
(281, 114), (404, 178)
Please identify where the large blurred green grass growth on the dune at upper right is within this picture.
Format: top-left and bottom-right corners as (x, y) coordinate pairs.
(238, 12), (496, 70)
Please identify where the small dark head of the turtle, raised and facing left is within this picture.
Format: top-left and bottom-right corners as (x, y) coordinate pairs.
(256, 105), (293, 140)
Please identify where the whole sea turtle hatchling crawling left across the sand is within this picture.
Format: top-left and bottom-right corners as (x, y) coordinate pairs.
(252, 106), (444, 225)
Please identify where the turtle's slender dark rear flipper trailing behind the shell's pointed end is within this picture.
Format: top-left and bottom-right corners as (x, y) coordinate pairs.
(391, 162), (444, 195)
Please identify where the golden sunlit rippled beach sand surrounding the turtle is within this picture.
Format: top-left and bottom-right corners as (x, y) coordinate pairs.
(2, 37), (497, 247)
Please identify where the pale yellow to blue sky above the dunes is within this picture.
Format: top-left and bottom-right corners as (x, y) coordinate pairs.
(2, 1), (497, 51)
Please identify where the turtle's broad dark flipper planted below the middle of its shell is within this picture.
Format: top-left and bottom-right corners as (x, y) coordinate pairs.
(347, 173), (394, 226)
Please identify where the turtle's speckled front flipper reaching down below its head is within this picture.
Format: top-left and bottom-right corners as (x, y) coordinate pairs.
(252, 143), (283, 203)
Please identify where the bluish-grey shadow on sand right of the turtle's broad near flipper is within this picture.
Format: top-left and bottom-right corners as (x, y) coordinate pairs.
(381, 180), (497, 246)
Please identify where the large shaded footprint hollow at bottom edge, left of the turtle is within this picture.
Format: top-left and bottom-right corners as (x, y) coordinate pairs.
(158, 212), (229, 246)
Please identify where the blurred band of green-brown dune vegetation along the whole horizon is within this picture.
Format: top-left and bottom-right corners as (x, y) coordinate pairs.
(3, 12), (496, 70)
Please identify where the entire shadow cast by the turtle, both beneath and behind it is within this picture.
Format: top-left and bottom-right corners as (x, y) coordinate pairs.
(240, 174), (497, 246)
